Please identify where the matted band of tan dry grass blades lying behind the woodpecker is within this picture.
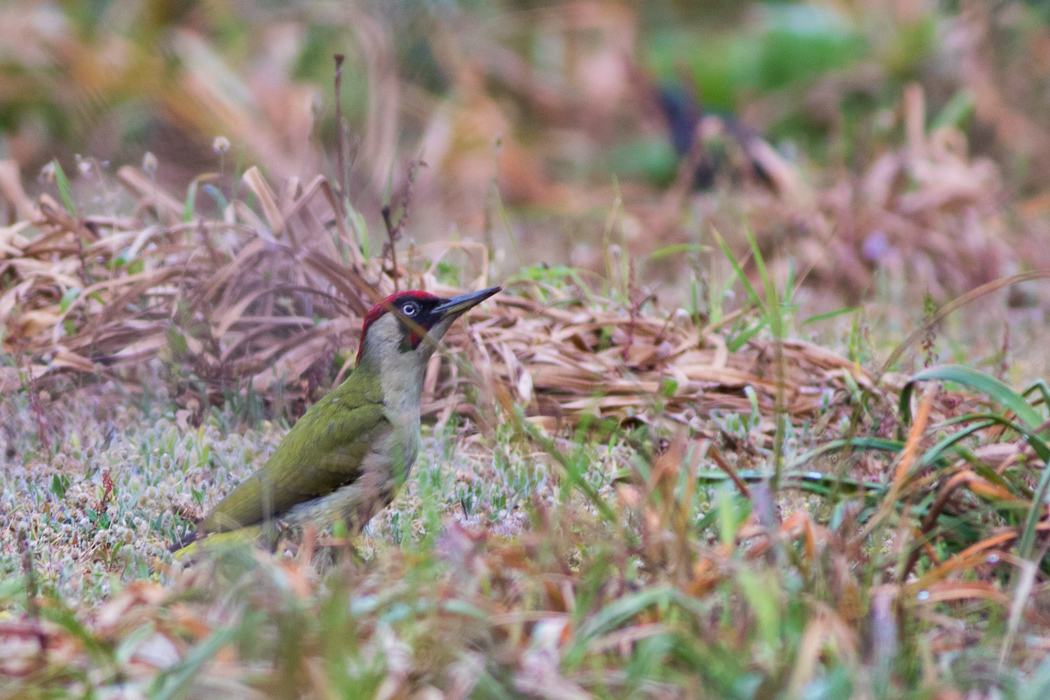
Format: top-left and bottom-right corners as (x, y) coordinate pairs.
(0, 164), (872, 432)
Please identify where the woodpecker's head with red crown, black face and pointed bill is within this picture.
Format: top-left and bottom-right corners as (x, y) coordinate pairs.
(357, 287), (501, 366)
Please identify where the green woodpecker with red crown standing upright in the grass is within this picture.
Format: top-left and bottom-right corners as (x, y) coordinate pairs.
(175, 287), (500, 558)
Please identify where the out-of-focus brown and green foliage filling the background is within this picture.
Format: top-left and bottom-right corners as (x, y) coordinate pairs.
(8, 0), (1050, 314)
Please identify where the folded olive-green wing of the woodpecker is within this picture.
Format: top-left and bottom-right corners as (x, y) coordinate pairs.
(200, 373), (391, 532)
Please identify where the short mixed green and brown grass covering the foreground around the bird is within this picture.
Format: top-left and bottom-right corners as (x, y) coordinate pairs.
(6, 255), (1047, 698)
